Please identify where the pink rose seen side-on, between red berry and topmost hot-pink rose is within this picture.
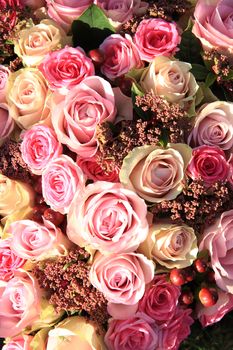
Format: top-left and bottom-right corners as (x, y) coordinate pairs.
(99, 34), (143, 80)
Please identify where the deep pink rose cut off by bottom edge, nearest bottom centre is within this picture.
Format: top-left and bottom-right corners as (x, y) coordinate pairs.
(104, 312), (161, 350)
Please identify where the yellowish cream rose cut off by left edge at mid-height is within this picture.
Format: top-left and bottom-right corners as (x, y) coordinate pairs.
(0, 174), (34, 216)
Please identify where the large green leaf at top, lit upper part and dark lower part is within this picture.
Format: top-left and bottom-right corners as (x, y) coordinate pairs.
(72, 5), (115, 51)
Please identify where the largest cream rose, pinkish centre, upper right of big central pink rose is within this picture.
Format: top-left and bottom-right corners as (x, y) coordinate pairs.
(120, 143), (192, 203)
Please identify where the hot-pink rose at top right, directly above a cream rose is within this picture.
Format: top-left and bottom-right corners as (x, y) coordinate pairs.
(134, 18), (181, 62)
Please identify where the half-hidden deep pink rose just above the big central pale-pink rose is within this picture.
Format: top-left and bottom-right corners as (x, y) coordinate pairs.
(76, 154), (120, 182)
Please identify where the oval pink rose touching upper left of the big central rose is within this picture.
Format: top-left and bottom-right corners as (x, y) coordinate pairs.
(42, 155), (85, 214)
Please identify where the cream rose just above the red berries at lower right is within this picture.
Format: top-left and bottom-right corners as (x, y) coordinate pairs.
(138, 223), (198, 269)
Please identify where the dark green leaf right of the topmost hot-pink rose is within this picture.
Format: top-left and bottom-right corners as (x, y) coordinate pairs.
(175, 23), (203, 64)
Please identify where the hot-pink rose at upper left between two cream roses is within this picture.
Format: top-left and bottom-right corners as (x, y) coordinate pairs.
(38, 46), (95, 90)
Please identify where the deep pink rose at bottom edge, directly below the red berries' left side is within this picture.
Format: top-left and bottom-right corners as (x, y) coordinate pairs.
(162, 309), (194, 350)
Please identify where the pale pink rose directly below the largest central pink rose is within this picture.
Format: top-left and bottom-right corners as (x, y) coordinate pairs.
(90, 253), (154, 318)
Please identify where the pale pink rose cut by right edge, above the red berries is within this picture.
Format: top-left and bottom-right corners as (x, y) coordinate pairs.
(199, 210), (233, 294)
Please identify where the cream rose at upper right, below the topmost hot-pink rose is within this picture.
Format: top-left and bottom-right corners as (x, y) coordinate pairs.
(140, 56), (198, 103)
